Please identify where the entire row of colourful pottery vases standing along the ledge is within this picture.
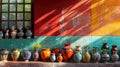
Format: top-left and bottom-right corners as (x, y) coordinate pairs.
(0, 43), (119, 63)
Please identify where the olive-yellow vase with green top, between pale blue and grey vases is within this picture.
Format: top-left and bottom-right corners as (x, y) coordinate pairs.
(83, 45), (91, 63)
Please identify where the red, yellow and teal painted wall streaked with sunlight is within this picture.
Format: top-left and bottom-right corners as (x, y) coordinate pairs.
(0, 0), (120, 50)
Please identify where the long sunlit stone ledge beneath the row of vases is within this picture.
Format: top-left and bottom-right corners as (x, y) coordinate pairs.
(0, 61), (120, 67)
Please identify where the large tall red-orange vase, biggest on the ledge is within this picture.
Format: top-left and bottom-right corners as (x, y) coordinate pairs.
(62, 44), (74, 62)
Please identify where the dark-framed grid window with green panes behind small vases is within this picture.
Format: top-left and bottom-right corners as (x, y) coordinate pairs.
(0, 0), (33, 38)
